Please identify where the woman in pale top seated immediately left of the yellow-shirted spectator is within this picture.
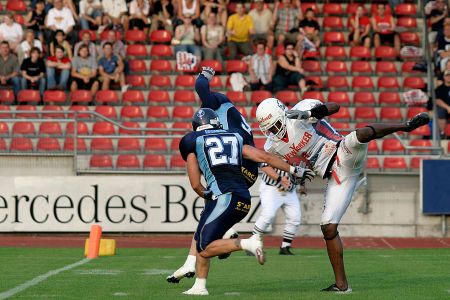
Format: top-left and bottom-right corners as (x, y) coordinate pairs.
(200, 12), (225, 62)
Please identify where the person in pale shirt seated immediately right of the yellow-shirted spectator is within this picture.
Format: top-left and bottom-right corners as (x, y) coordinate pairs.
(248, 0), (274, 49)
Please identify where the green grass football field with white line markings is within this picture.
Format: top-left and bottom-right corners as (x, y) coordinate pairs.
(0, 248), (450, 300)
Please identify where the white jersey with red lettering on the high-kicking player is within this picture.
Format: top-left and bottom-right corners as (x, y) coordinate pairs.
(264, 100), (344, 178)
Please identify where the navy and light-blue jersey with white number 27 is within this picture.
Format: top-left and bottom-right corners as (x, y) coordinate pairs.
(180, 129), (250, 199)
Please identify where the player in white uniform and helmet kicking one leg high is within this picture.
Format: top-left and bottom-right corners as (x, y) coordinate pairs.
(256, 98), (430, 293)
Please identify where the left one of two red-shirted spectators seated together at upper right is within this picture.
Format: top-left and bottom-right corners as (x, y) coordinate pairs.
(348, 5), (370, 48)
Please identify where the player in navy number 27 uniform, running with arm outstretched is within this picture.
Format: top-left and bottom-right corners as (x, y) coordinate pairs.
(180, 108), (313, 295)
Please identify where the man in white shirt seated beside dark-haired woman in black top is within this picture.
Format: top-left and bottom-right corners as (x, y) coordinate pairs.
(248, 40), (275, 91)
